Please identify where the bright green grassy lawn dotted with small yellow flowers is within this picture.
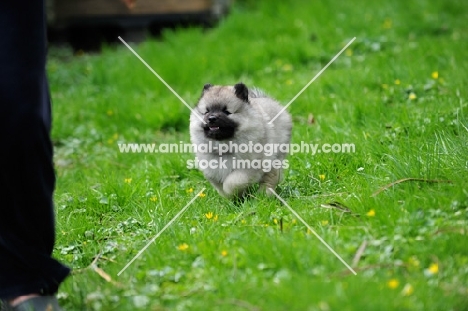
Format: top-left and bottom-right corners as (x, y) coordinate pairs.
(48, 0), (468, 310)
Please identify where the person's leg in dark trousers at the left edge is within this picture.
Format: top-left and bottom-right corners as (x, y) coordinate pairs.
(0, 0), (70, 300)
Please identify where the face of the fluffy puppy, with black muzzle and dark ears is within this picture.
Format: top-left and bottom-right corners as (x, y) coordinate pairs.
(197, 83), (249, 140)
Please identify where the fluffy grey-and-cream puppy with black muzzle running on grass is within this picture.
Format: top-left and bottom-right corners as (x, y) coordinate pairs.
(190, 83), (292, 198)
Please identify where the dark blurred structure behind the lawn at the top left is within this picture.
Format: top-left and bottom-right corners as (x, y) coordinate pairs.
(47, 0), (232, 51)
